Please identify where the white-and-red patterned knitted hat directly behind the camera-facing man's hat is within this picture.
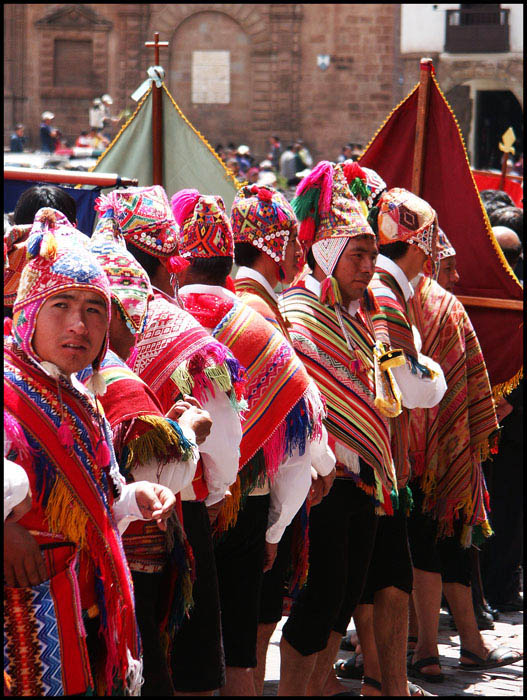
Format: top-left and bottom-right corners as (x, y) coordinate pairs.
(90, 217), (154, 335)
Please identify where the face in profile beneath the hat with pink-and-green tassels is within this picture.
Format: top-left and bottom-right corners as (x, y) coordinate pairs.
(333, 236), (379, 305)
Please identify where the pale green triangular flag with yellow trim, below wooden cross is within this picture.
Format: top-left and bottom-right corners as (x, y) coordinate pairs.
(90, 84), (241, 211)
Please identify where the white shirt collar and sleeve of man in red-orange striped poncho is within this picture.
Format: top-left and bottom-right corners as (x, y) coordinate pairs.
(180, 284), (316, 543)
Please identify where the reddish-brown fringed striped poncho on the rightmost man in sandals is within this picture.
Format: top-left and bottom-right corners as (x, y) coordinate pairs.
(410, 277), (498, 546)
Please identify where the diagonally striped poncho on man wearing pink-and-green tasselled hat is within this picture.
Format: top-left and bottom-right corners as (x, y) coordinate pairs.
(280, 280), (397, 514)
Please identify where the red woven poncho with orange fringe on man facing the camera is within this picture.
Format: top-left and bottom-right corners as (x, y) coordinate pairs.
(4, 339), (140, 695)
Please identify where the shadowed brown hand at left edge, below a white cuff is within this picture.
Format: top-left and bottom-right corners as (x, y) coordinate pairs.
(4, 519), (49, 588)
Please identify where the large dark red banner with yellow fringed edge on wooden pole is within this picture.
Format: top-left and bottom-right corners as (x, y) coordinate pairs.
(359, 71), (523, 395)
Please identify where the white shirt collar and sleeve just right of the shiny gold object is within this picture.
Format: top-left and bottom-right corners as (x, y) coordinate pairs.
(374, 255), (446, 409)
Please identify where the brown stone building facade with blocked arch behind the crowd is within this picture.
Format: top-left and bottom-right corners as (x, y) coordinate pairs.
(4, 3), (402, 159)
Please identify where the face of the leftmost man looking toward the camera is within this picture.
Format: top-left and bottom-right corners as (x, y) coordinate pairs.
(32, 289), (108, 374)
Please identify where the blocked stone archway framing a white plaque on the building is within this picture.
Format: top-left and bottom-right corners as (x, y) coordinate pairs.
(167, 11), (252, 147)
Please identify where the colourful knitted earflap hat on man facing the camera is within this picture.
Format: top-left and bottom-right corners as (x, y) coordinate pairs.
(13, 208), (110, 393)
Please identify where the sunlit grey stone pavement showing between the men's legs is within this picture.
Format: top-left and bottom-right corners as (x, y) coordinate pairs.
(264, 600), (523, 697)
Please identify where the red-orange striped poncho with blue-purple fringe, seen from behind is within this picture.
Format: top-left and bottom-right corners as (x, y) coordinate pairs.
(181, 288), (324, 530)
